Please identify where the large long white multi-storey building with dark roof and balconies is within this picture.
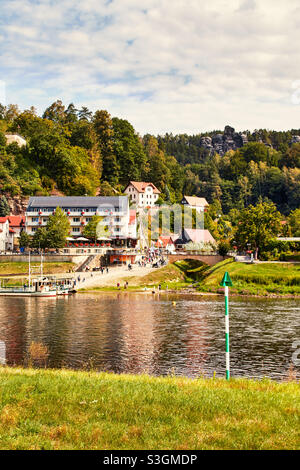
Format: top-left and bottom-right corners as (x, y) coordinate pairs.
(26, 196), (129, 239)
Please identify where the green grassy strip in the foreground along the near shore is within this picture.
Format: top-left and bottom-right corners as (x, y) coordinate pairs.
(0, 368), (300, 450)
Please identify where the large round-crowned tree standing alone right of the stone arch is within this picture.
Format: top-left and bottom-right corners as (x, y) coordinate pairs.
(235, 201), (281, 259)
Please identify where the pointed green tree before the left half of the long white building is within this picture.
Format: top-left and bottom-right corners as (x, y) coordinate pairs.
(46, 207), (70, 248)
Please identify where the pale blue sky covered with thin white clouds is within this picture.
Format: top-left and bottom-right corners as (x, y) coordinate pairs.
(0, 0), (300, 135)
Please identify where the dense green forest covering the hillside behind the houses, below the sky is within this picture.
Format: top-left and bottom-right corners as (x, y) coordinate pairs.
(0, 100), (300, 216)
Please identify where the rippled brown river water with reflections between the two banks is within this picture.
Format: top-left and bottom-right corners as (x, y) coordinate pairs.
(0, 293), (300, 380)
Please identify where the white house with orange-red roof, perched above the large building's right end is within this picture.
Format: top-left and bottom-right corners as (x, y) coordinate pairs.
(125, 181), (160, 207)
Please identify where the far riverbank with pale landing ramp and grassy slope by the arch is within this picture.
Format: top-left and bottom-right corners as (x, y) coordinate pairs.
(79, 259), (300, 297)
